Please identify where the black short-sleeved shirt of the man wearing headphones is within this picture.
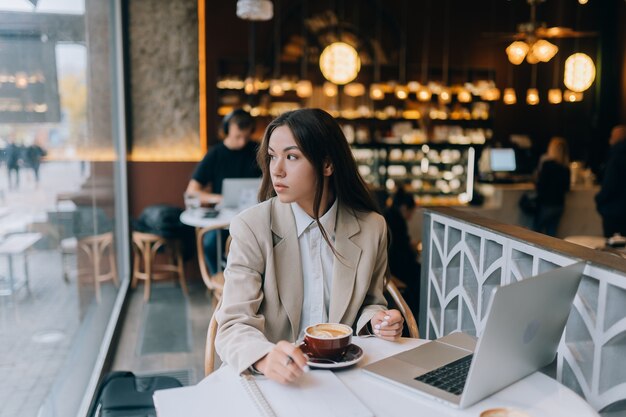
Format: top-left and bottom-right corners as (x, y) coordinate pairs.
(192, 142), (261, 194)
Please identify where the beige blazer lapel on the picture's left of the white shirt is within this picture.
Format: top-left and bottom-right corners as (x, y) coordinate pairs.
(271, 199), (304, 340)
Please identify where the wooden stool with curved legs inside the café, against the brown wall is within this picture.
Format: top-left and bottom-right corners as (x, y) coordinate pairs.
(131, 232), (188, 301)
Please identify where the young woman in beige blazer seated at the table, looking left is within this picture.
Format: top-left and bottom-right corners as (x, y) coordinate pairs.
(216, 109), (403, 383)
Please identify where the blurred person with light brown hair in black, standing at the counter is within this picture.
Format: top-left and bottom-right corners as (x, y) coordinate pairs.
(533, 137), (570, 236)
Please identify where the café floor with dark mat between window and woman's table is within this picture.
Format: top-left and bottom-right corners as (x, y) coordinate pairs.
(113, 281), (213, 385)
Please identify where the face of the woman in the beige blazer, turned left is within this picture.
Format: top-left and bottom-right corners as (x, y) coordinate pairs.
(268, 126), (326, 217)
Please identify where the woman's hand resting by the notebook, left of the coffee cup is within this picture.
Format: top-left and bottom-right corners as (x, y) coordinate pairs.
(254, 340), (309, 384)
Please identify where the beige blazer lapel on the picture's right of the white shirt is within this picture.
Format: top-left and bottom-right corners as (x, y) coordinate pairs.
(328, 205), (362, 323)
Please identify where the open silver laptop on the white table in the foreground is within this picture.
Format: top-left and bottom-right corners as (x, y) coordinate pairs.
(364, 262), (585, 408)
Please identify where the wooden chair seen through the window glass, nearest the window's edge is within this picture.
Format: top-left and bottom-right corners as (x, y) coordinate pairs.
(76, 232), (120, 303)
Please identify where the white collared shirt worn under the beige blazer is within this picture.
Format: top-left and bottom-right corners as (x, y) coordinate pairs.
(291, 200), (337, 340)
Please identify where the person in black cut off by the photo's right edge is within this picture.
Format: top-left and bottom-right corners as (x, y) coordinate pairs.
(596, 125), (626, 237)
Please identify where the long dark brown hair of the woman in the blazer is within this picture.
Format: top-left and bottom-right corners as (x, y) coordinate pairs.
(257, 109), (380, 247)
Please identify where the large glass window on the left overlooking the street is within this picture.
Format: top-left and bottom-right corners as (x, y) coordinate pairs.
(0, 0), (129, 417)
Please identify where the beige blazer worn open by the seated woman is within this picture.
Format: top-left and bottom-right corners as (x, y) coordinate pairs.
(215, 198), (387, 373)
